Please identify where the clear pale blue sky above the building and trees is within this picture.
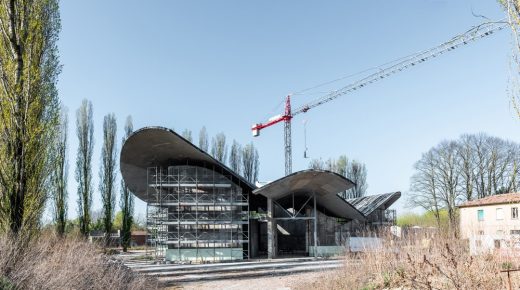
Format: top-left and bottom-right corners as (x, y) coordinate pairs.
(47, 0), (520, 222)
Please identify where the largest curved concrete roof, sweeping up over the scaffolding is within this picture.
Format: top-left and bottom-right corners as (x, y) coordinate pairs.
(119, 127), (256, 201)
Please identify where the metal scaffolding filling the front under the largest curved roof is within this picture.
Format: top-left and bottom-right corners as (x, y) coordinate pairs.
(147, 165), (249, 263)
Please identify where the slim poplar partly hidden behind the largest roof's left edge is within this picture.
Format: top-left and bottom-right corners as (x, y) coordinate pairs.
(119, 116), (134, 252)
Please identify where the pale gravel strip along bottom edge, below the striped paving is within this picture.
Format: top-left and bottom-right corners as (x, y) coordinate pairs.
(168, 272), (327, 290)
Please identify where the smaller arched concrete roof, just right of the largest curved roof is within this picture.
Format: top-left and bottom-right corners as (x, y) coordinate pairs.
(253, 169), (365, 220)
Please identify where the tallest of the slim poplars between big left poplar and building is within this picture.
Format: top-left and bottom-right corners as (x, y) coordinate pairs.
(76, 100), (94, 237)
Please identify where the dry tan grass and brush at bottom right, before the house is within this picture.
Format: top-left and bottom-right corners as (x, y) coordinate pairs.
(301, 238), (520, 290)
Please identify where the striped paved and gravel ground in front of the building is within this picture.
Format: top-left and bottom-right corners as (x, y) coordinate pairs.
(120, 253), (343, 290)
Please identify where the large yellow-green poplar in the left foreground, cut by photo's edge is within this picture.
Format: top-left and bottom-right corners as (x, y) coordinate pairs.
(0, 0), (61, 234)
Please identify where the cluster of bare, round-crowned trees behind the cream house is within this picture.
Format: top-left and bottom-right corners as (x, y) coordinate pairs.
(409, 134), (520, 232)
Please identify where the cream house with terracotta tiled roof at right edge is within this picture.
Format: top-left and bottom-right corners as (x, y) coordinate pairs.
(459, 193), (520, 254)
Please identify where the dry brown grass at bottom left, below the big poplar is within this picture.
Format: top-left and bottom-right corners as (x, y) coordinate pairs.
(0, 236), (158, 289)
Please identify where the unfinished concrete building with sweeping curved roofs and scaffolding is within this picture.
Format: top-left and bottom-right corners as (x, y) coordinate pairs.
(120, 127), (401, 262)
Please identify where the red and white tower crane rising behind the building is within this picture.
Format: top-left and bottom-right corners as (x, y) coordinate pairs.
(251, 19), (508, 175)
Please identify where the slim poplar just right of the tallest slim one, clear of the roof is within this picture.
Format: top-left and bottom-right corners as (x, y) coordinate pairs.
(99, 113), (117, 246)
